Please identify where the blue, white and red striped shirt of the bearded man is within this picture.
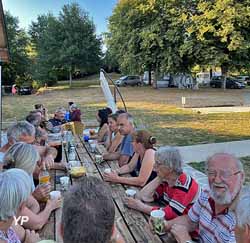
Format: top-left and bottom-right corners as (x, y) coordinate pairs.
(188, 191), (236, 243)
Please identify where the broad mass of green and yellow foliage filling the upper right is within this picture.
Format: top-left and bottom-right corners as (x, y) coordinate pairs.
(107, 0), (250, 76)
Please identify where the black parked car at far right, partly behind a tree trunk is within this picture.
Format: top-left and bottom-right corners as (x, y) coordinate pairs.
(210, 76), (245, 89)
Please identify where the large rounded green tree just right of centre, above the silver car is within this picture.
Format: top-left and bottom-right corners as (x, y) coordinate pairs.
(107, 0), (199, 84)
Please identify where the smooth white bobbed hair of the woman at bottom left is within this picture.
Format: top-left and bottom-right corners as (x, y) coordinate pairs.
(0, 169), (31, 221)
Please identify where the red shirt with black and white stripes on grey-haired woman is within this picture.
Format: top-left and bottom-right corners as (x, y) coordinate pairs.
(153, 173), (199, 220)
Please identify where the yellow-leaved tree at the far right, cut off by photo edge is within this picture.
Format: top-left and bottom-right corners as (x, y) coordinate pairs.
(187, 0), (250, 82)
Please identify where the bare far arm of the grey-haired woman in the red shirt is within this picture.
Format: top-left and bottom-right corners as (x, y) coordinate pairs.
(137, 176), (162, 202)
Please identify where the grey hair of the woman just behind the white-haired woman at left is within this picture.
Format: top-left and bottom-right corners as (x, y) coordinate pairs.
(3, 142), (40, 175)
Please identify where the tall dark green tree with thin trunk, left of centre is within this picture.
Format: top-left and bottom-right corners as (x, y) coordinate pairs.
(57, 3), (101, 86)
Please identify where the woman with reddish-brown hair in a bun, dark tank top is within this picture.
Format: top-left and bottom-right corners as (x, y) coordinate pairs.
(104, 130), (157, 187)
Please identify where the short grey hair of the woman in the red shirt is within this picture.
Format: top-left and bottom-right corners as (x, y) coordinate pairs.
(155, 146), (183, 175)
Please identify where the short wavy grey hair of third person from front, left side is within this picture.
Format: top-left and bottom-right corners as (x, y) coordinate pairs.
(7, 121), (36, 142)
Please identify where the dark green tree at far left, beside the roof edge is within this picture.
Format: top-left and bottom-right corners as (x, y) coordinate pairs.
(3, 11), (30, 84)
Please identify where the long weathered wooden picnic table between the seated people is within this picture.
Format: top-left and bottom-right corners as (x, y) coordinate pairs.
(39, 132), (176, 243)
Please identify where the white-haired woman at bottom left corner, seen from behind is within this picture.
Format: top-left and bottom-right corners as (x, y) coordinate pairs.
(0, 169), (40, 243)
